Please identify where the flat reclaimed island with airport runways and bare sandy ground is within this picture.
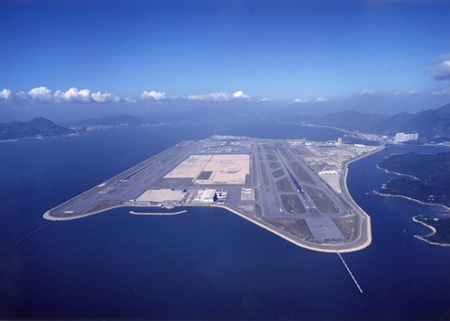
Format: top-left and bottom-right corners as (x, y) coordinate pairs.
(44, 136), (381, 253)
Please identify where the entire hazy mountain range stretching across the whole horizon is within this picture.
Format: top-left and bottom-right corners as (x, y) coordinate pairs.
(0, 104), (450, 141)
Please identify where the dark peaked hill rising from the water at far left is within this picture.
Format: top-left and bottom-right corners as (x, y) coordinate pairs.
(0, 117), (75, 140)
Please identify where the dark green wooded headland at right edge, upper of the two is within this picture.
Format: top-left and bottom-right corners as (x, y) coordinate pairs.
(377, 152), (450, 208)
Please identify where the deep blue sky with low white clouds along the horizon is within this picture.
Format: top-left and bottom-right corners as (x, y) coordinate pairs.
(0, 0), (450, 117)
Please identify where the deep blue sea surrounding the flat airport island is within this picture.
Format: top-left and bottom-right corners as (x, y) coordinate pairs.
(0, 121), (450, 320)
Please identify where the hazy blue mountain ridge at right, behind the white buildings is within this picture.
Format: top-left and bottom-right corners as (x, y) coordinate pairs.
(315, 104), (450, 140)
